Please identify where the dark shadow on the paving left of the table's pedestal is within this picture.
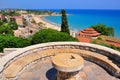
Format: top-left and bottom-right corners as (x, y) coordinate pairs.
(46, 68), (57, 80)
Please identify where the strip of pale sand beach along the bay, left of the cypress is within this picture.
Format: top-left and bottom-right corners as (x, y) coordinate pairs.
(34, 15), (60, 31)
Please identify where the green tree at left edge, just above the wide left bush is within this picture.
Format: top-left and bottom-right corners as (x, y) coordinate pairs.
(0, 24), (14, 35)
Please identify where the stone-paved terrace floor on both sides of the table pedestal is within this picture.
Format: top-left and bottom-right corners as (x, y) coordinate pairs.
(18, 59), (120, 80)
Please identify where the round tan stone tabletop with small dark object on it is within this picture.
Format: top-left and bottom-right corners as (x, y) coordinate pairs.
(52, 53), (84, 72)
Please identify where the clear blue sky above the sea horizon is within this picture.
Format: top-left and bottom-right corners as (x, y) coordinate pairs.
(0, 0), (120, 9)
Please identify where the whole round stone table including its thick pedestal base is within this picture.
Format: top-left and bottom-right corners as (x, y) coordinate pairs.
(52, 53), (84, 80)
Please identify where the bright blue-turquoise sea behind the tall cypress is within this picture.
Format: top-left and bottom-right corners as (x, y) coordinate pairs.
(44, 9), (120, 38)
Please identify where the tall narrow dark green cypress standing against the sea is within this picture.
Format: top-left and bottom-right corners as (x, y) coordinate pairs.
(61, 10), (70, 34)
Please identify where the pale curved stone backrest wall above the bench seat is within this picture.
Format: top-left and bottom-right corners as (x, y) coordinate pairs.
(0, 42), (120, 77)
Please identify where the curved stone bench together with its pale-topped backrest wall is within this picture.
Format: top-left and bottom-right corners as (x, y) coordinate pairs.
(0, 42), (120, 80)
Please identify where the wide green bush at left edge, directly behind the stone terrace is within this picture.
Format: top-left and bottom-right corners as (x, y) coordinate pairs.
(0, 35), (30, 52)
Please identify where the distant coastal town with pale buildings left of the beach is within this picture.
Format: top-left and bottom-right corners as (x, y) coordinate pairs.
(0, 9), (60, 38)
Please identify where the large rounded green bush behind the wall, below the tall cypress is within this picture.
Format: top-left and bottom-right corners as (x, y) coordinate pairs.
(31, 29), (78, 44)
